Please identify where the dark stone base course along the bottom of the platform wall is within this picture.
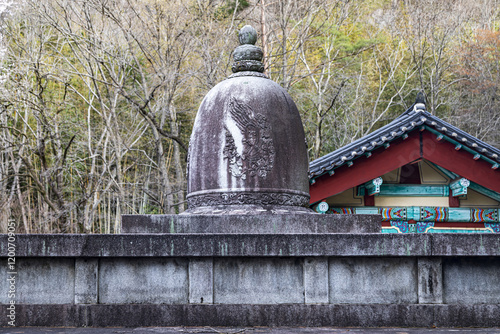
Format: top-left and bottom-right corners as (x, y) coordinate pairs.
(0, 304), (500, 327)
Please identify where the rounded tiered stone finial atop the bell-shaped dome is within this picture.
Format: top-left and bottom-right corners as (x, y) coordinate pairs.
(231, 25), (264, 73)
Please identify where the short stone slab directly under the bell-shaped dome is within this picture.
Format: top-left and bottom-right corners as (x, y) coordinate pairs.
(122, 214), (382, 234)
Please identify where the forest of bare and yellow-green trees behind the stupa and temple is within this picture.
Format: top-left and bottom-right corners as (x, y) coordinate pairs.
(0, 0), (500, 233)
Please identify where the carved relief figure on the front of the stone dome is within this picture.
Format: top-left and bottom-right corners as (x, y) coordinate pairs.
(223, 97), (276, 180)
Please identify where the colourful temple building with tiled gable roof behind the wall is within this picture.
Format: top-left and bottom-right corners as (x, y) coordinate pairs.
(309, 93), (500, 233)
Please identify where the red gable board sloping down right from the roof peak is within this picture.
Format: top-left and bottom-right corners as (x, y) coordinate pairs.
(422, 131), (500, 192)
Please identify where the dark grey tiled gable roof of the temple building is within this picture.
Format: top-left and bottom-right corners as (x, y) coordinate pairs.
(309, 103), (500, 180)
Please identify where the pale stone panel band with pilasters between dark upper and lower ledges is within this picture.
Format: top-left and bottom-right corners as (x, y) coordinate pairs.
(0, 257), (500, 305)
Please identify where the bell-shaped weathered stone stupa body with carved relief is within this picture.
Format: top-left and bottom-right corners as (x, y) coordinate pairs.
(187, 26), (309, 213)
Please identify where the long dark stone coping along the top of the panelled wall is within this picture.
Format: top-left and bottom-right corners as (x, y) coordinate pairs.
(0, 233), (500, 257)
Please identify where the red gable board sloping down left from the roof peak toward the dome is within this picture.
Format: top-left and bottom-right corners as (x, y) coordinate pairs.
(309, 131), (422, 204)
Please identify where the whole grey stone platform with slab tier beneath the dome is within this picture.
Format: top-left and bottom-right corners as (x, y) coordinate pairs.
(0, 215), (500, 327)
